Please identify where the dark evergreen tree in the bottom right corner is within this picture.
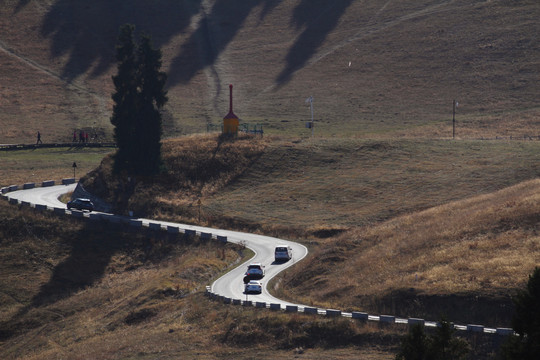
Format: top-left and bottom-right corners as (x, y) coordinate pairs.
(502, 267), (540, 360)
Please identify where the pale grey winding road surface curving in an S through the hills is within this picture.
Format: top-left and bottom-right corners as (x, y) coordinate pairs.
(5, 184), (308, 308)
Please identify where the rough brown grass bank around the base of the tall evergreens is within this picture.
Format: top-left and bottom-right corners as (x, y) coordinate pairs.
(81, 134), (267, 222)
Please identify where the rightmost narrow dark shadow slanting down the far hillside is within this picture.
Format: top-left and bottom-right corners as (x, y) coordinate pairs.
(276, 0), (353, 85)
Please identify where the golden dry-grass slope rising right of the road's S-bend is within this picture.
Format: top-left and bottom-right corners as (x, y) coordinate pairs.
(276, 179), (540, 324)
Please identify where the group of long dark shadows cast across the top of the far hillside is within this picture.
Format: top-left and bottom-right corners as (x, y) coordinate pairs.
(15, 0), (352, 86)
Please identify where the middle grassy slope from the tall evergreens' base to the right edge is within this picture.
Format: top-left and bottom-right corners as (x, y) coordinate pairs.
(82, 135), (540, 236)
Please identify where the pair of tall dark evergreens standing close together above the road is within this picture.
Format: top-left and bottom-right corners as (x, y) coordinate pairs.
(111, 24), (167, 175)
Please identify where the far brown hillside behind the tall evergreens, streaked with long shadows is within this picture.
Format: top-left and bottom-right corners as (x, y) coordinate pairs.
(0, 0), (540, 143)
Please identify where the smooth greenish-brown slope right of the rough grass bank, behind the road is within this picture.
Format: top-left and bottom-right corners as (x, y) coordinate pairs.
(203, 135), (540, 229)
